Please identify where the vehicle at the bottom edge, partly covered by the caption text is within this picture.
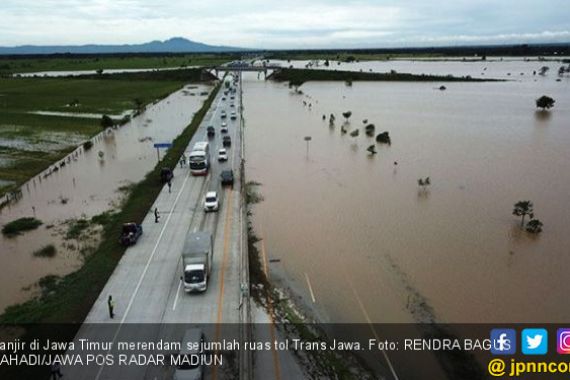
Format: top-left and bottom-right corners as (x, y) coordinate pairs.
(173, 327), (206, 380)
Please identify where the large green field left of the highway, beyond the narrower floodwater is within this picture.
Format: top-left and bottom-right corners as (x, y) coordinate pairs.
(0, 70), (204, 196)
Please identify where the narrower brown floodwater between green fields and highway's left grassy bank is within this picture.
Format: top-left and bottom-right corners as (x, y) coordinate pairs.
(0, 85), (211, 311)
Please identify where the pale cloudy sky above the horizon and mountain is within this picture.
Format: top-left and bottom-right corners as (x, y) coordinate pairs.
(0, 0), (570, 49)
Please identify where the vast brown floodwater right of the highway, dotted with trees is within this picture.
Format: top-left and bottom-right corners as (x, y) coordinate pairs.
(244, 62), (570, 323)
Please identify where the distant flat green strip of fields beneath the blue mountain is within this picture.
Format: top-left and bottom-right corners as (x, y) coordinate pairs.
(0, 54), (232, 76)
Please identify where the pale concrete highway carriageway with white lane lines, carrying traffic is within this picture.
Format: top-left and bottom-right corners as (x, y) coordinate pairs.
(64, 74), (243, 379)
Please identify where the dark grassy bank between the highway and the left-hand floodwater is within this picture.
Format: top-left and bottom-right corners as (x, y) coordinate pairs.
(0, 81), (218, 324)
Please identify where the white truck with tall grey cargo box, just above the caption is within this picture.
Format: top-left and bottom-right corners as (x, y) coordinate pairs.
(182, 232), (214, 292)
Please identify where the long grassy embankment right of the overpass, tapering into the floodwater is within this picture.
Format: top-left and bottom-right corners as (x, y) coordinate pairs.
(271, 69), (493, 85)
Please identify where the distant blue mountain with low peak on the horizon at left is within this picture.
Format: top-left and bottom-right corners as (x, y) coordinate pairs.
(0, 37), (247, 55)
